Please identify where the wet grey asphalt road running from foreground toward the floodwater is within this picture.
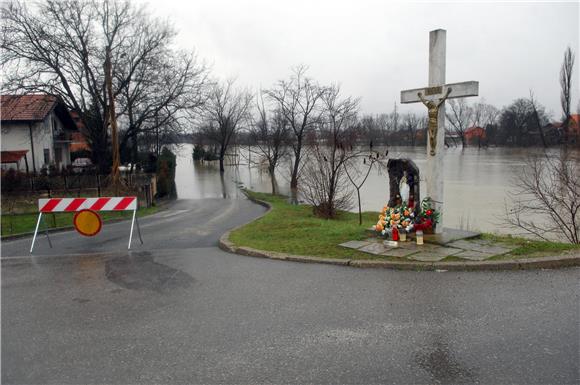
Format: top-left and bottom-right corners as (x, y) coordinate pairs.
(1, 199), (580, 384)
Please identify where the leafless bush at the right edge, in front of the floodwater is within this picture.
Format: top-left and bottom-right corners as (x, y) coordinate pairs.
(505, 151), (580, 244)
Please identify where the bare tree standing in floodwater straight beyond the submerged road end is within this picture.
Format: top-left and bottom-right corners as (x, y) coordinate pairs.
(201, 80), (253, 173)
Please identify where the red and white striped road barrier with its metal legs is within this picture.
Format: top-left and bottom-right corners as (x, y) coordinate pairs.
(30, 197), (143, 253)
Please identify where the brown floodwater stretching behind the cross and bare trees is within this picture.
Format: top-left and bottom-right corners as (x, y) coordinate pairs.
(176, 145), (580, 233)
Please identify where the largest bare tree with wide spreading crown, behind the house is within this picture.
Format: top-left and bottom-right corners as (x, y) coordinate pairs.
(1, 0), (206, 169)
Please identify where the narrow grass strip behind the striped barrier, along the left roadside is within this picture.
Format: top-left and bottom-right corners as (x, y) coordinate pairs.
(1, 206), (160, 236)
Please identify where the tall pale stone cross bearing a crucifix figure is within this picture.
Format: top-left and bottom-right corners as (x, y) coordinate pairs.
(401, 29), (479, 233)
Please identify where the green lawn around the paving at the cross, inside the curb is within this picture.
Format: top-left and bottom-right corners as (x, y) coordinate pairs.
(230, 191), (580, 261)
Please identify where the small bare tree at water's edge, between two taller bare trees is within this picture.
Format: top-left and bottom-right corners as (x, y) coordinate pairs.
(249, 92), (290, 194)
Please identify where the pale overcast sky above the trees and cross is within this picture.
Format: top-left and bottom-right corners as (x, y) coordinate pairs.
(141, 0), (580, 118)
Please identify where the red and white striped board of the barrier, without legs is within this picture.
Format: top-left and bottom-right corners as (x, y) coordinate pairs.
(38, 197), (137, 213)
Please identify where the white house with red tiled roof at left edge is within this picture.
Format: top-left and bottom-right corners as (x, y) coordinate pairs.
(0, 94), (78, 173)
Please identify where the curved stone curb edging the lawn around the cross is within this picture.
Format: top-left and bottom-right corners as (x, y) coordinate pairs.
(219, 194), (580, 271)
